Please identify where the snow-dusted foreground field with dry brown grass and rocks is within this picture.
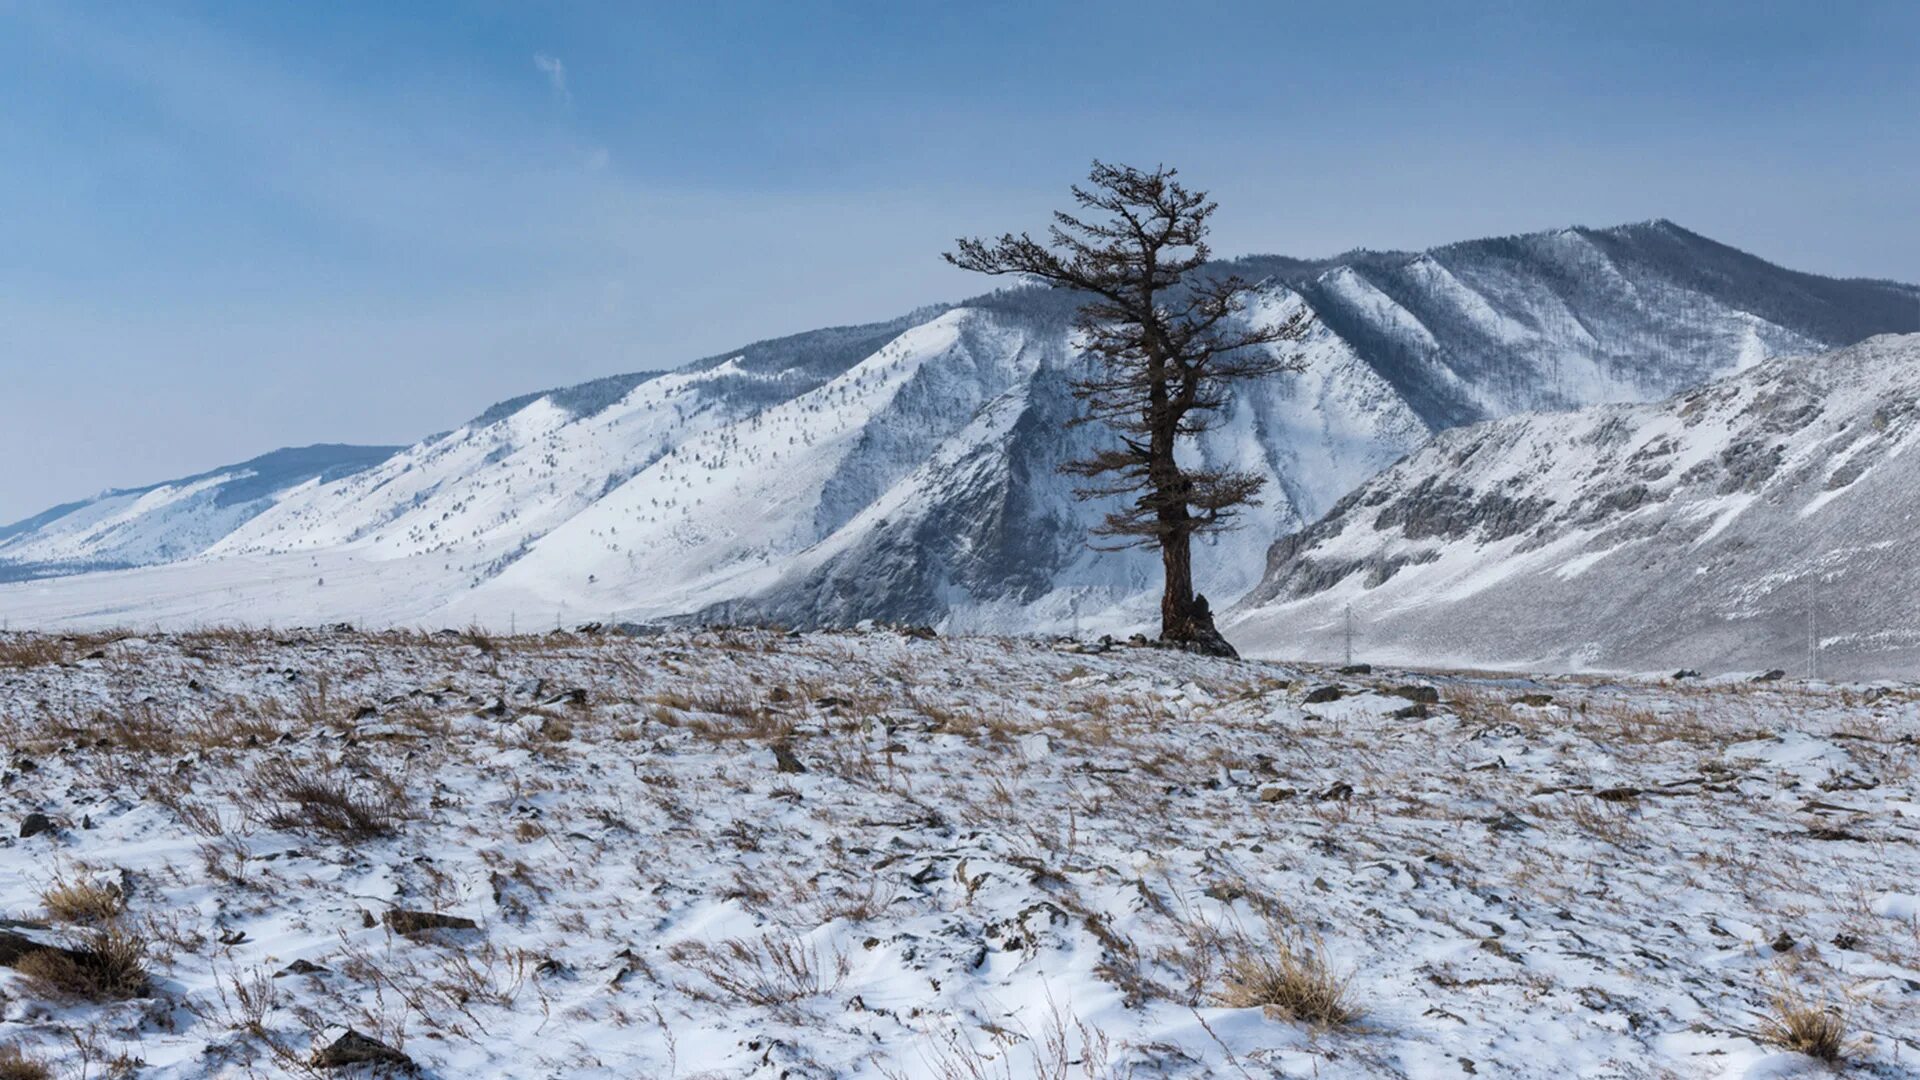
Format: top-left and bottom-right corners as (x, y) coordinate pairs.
(0, 628), (1920, 1080)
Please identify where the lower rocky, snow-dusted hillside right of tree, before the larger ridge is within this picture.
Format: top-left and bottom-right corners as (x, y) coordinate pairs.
(1229, 334), (1920, 676)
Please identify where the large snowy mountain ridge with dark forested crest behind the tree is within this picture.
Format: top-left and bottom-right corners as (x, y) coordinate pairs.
(0, 221), (1920, 630)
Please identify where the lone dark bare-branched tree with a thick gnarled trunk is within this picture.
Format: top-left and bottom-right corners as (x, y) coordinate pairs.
(945, 161), (1308, 655)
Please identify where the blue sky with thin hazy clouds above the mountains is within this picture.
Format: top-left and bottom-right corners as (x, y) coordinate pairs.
(0, 0), (1920, 521)
